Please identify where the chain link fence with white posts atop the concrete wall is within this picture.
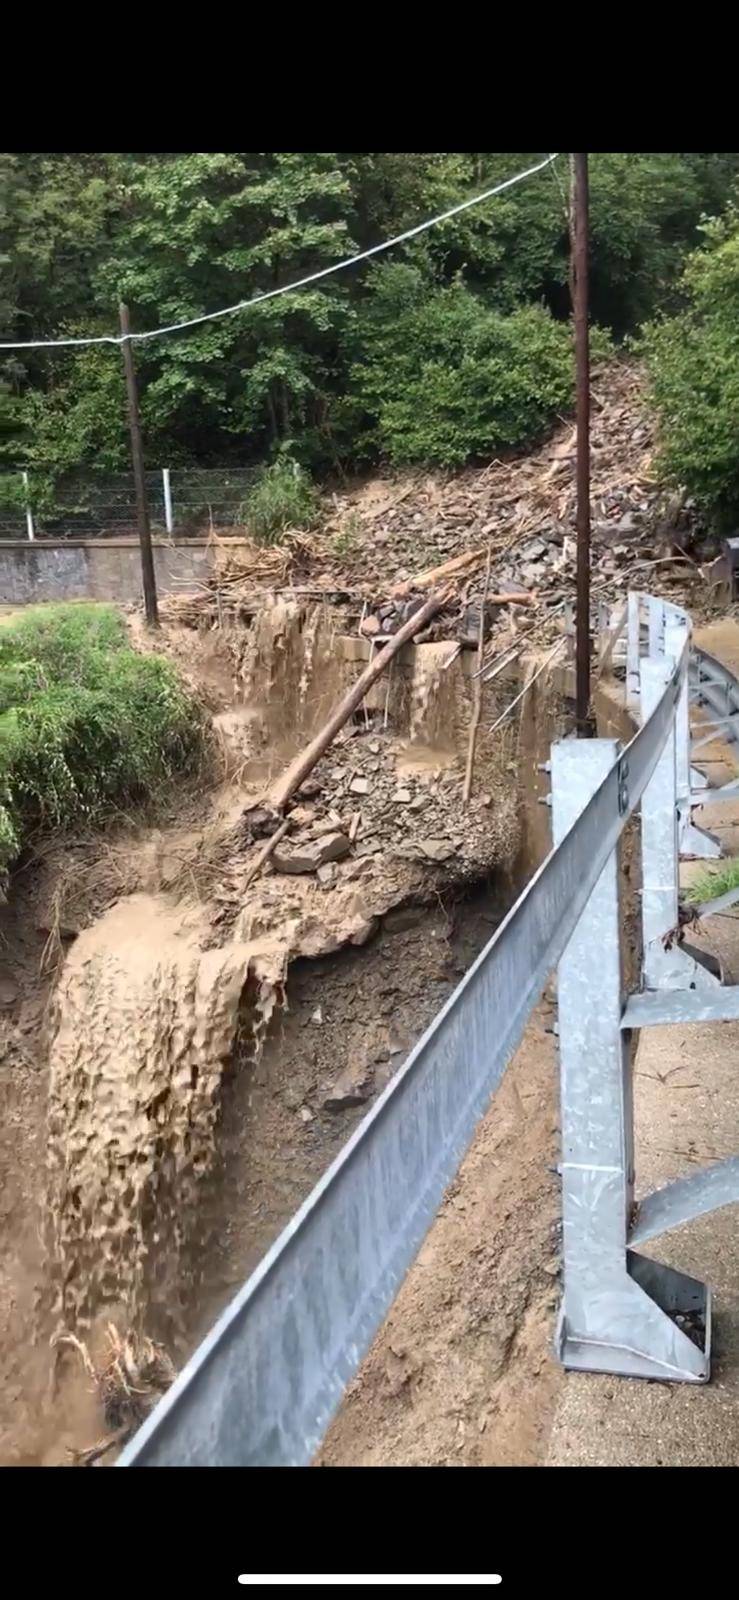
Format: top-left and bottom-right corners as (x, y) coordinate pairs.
(0, 467), (256, 539)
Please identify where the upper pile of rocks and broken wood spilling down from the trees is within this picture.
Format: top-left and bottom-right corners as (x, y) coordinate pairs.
(163, 362), (697, 648)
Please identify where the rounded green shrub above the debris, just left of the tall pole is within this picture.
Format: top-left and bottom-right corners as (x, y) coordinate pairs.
(354, 266), (573, 467)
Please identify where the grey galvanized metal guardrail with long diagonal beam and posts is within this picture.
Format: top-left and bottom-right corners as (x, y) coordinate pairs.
(118, 597), (739, 1466)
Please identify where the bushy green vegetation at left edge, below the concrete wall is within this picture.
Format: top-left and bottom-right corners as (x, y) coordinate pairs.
(0, 605), (202, 877)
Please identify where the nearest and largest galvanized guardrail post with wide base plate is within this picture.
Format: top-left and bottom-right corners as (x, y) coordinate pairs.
(552, 739), (710, 1382)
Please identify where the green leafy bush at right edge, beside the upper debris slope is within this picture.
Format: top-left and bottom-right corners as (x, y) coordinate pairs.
(643, 208), (739, 528)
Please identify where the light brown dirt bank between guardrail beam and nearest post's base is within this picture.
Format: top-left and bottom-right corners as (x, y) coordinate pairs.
(317, 1006), (560, 1467)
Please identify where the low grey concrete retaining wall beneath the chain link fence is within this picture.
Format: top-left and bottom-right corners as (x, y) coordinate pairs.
(0, 539), (225, 605)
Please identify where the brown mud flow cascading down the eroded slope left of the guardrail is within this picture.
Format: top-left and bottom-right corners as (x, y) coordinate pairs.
(0, 598), (565, 1464)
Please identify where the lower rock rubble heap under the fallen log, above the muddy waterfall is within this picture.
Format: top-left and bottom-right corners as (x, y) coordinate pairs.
(213, 694), (520, 942)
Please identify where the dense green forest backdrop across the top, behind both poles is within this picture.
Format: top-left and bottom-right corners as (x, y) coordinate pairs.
(0, 152), (739, 489)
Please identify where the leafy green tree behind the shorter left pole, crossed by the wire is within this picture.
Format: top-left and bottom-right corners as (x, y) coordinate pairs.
(98, 154), (354, 459)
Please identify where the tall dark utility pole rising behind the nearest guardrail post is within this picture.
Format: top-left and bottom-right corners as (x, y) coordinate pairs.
(571, 155), (590, 738)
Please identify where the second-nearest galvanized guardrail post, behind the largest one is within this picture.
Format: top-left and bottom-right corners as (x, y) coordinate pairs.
(641, 640), (720, 989)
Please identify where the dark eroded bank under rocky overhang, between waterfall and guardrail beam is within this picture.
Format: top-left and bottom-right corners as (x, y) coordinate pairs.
(188, 885), (524, 1350)
